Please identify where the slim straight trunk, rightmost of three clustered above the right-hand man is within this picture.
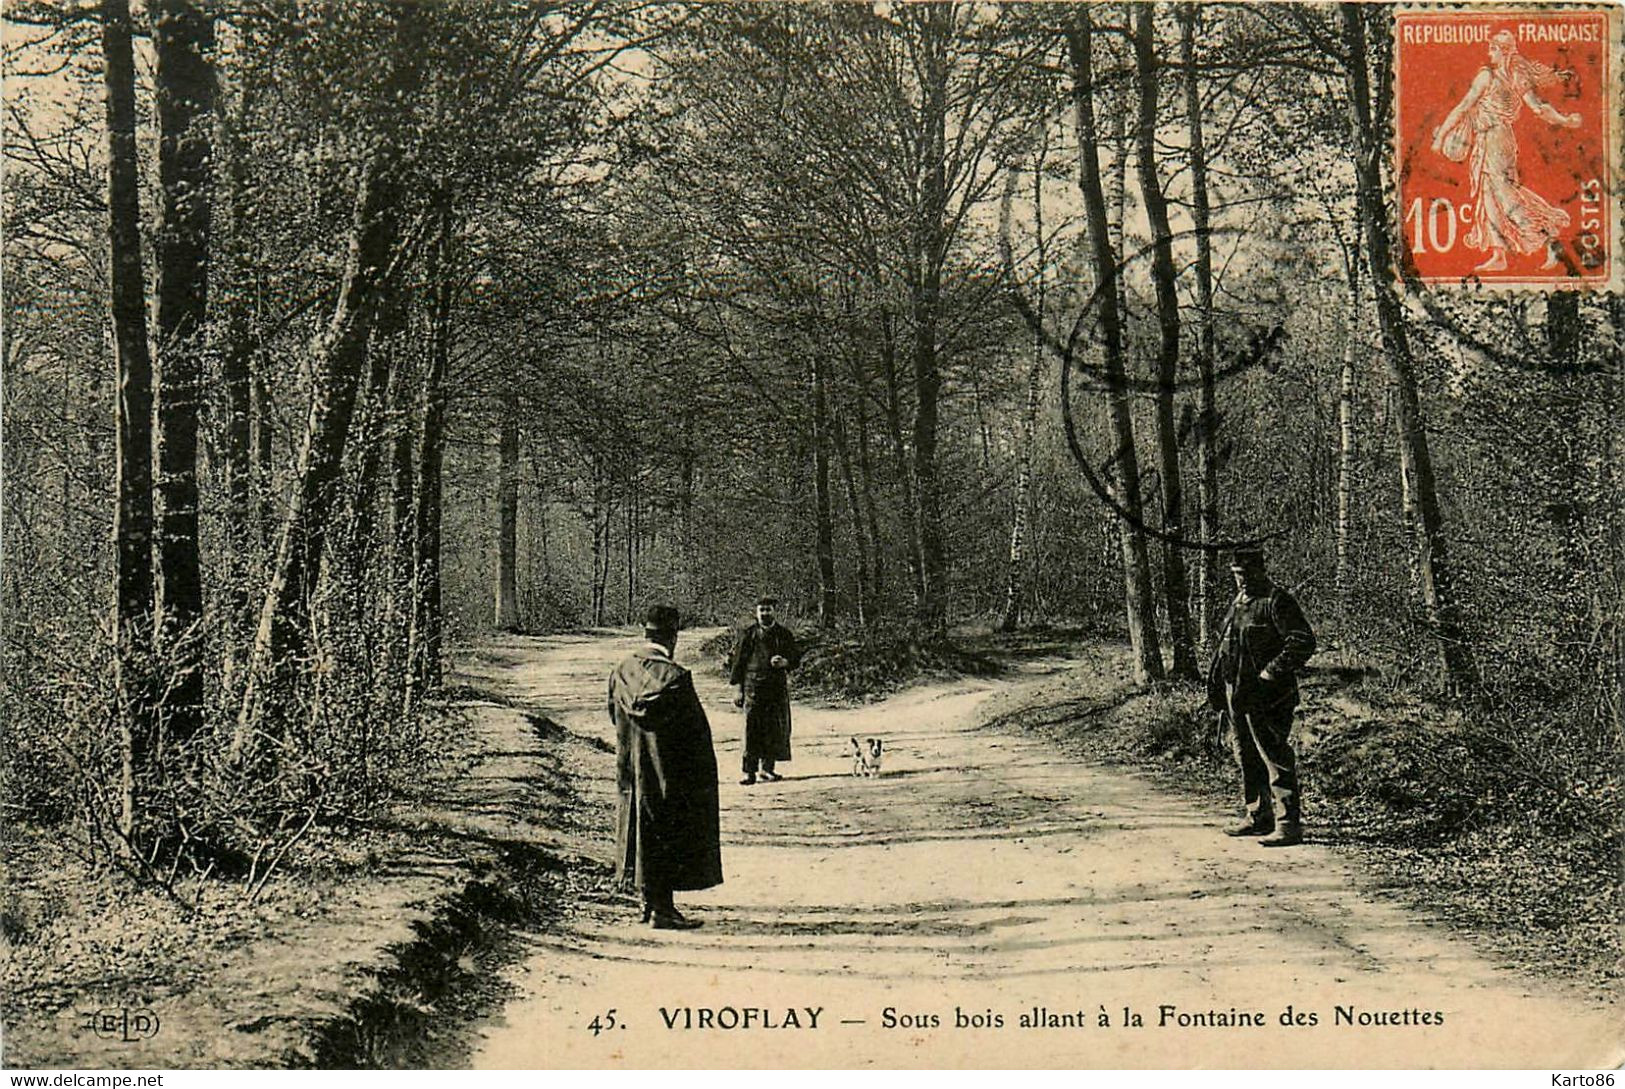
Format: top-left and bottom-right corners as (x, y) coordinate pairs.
(1180, 3), (1222, 650)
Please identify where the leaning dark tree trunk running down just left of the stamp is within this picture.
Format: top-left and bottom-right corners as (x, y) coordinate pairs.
(1339, 2), (1476, 692)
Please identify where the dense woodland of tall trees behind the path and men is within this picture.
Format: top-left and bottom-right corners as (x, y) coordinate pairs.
(0, 0), (1625, 887)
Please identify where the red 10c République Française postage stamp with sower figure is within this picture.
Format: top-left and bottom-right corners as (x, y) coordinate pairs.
(1394, 5), (1620, 291)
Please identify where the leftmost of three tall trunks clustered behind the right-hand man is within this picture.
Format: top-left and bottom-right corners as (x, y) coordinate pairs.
(1066, 8), (1164, 684)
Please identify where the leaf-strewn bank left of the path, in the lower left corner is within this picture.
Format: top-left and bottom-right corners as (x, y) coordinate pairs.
(0, 659), (601, 1068)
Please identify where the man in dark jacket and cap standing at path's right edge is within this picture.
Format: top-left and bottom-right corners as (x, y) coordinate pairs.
(1207, 548), (1315, 847)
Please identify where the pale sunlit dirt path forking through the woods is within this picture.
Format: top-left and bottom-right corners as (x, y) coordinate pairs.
(475, 632), (1622, 1069)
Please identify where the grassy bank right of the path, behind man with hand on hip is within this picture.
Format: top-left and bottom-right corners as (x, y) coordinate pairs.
(990, 640), (1625, 996)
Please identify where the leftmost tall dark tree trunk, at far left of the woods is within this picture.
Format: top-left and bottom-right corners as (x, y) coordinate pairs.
(102, 0), (153, 840)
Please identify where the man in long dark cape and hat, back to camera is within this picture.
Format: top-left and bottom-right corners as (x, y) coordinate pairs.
(609, 605), (722, 930)
